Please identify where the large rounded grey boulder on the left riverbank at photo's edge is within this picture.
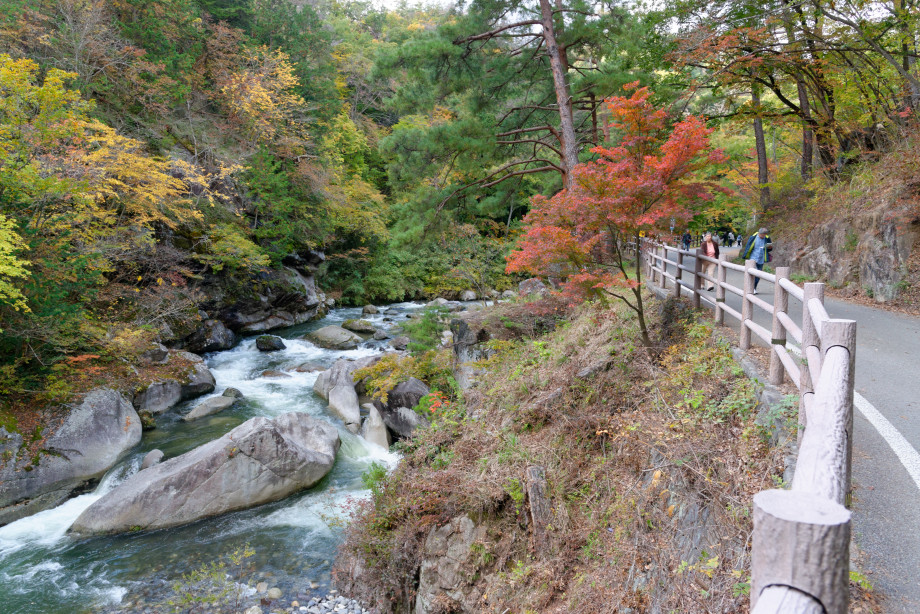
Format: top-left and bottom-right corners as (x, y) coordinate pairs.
(0, 388), (141, 525)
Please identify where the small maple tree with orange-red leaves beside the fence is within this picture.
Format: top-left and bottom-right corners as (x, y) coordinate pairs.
(507, 82), (726, 345)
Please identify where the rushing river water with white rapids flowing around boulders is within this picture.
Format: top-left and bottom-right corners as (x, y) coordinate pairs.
(0, 303), (422, 614)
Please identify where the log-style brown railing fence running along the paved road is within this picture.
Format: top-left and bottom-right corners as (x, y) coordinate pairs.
(641, 240), (856, 614)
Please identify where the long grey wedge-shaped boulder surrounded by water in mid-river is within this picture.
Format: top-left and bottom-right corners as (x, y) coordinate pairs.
(70, 412), (340, 534)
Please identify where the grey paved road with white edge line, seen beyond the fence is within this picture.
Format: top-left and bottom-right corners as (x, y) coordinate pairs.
(669, 250), (920, 614)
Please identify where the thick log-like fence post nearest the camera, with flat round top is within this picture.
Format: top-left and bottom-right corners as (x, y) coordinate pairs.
(751, 490), (850, 614)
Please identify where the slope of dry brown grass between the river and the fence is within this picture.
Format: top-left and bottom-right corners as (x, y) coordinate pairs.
(339, 296), (800, 613)
